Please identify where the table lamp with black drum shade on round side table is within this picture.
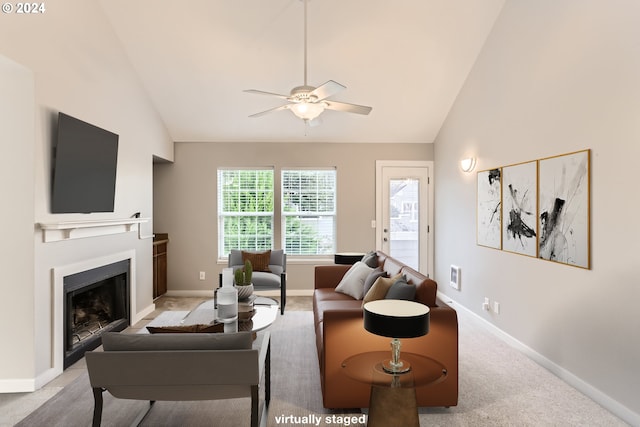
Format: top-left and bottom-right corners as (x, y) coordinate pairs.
(364, 299), (429, 374)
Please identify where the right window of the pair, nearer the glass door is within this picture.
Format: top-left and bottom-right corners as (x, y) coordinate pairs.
(281, 169), (336, 255)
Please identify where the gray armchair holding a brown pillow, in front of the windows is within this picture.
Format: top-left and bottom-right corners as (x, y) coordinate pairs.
(221, 249), (287, 314)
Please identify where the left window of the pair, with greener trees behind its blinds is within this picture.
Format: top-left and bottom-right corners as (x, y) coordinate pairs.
(218, 169), (273, 257)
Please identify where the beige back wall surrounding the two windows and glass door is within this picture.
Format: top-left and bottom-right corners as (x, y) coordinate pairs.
(154, 142), (433, 293)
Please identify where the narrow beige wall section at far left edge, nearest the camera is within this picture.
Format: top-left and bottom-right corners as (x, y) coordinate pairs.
(0, 55), (35, 382)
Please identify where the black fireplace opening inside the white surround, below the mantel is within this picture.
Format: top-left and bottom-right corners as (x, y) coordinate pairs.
(63, 260), (130, 369)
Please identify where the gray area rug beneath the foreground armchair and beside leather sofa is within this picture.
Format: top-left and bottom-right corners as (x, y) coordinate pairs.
(17, 311), (364, 427)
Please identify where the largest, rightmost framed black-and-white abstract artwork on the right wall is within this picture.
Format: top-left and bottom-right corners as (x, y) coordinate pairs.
(538, 150), (591, 268)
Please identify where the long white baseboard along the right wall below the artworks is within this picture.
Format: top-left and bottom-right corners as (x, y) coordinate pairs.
(438, 291), (640, 426)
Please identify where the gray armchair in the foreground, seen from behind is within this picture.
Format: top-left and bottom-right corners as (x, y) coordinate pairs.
(85, 332), (271, 427)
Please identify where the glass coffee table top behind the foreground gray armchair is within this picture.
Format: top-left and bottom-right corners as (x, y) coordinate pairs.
(147, 296), (278, 333)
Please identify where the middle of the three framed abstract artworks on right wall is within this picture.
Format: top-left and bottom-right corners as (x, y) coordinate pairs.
(502, 161), (538, 257)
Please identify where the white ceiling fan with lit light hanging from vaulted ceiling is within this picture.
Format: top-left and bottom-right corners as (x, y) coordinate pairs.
(245, 0), (372, 123)
